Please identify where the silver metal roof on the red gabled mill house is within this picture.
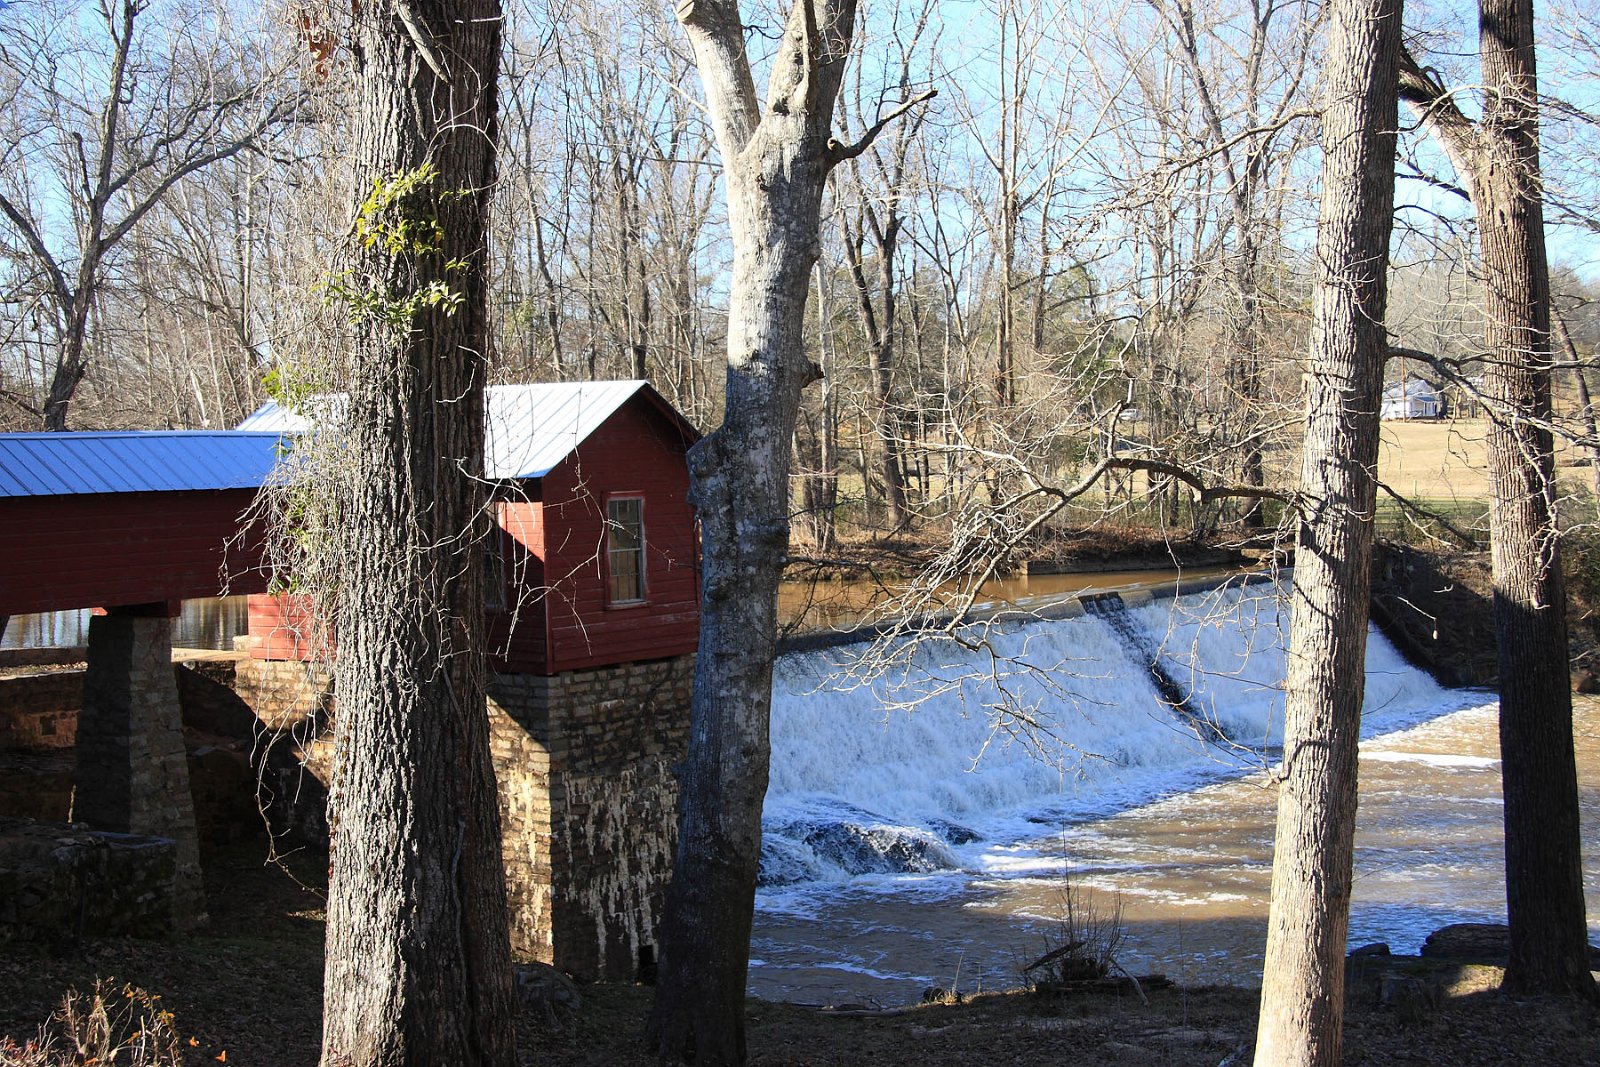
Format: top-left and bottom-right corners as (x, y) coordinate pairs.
(238, 381), (646, 478)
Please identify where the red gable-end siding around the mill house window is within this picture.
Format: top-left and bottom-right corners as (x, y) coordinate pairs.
(542, 397), (699, 673)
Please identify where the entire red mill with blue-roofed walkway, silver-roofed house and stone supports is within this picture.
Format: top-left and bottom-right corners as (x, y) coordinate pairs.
(0, 381), (699, 977)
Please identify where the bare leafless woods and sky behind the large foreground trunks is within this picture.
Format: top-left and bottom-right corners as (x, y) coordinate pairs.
(0, 0), (1600, 552)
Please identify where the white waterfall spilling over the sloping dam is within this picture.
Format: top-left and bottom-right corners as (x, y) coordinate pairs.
(762, 584), (1459, 893)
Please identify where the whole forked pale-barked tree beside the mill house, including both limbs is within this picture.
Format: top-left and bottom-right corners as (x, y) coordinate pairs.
(648, 0), (856, 1064)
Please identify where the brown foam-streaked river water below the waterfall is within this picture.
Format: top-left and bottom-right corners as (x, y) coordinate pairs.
(750, 694), (1600, 1005)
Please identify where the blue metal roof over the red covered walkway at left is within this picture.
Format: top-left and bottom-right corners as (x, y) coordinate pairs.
(0, 430), (283, 498)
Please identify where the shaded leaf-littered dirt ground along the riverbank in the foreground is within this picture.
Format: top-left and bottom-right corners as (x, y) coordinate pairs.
(0, 846), (1600, 1067)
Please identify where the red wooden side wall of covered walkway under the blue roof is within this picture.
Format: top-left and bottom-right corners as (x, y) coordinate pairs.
(0, 490), (266, 614)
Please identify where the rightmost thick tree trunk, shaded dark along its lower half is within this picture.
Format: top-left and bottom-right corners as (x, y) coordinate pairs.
(1474, 0), (1595, 997)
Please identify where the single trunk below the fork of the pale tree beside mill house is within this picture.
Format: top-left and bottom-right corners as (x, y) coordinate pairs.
(651, 118), (826, 1064)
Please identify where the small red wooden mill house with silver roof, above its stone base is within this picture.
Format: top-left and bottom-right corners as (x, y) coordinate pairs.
(238, 381), (699, 675)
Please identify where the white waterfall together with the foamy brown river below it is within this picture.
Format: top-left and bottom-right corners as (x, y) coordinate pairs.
(750, 584), (1523, 1003)
